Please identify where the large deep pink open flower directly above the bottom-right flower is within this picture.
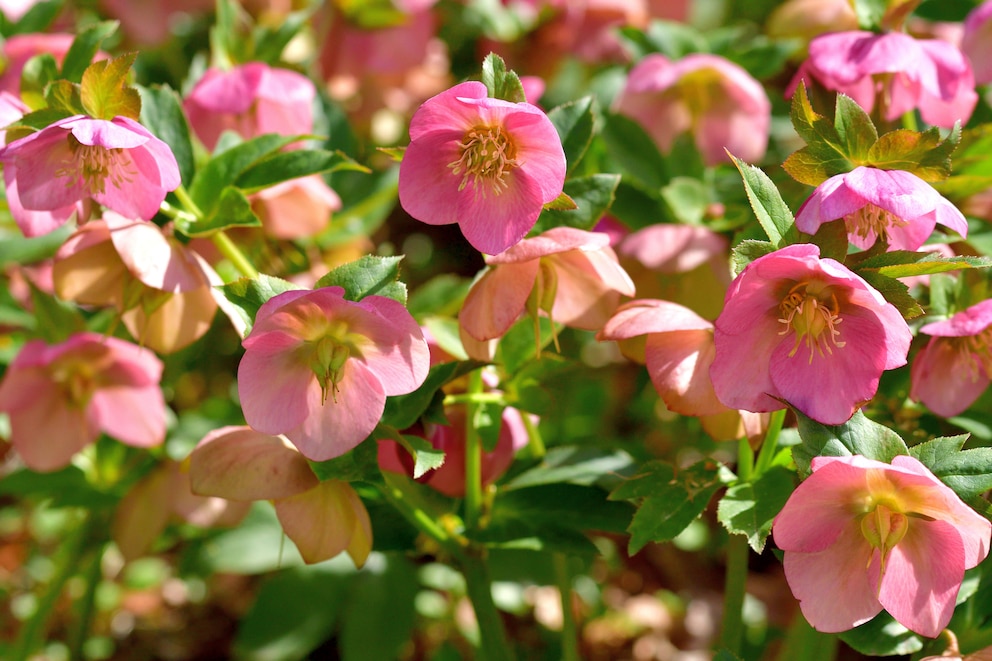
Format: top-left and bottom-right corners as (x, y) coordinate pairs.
(710, 243), (912, 425)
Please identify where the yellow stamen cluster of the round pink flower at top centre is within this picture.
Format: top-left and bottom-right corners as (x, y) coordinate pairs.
(448, 126), (520, 196)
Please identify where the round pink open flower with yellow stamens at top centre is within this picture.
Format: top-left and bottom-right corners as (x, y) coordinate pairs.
(399, 82), (565, 255)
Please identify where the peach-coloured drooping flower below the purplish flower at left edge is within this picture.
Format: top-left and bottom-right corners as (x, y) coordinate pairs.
(53, 211), (220, 353)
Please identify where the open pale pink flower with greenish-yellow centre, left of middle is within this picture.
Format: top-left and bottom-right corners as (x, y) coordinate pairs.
(238, 287), (430, 461)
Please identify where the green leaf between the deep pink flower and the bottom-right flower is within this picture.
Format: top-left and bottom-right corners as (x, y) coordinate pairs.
(792, 409), (909, 478)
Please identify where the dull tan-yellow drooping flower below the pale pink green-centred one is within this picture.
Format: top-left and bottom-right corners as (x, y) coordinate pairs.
(189, 427), (372, 567)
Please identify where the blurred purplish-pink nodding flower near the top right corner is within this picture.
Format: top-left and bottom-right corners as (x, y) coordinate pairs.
(787, 31), (978, 128)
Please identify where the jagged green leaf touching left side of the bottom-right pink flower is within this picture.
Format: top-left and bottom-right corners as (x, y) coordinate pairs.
(717, 466), (795, 553)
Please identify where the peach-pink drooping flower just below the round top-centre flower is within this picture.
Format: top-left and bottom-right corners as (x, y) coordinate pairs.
(458, 227), (634, 341)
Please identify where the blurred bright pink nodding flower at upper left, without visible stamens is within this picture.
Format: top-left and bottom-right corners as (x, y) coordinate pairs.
(183, 62), (317, 150)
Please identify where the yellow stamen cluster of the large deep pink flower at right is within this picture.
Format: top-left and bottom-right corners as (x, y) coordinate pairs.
(778, 282), (846, 363)
